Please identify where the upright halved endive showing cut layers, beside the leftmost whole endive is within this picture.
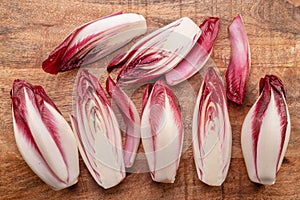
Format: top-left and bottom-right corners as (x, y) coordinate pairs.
(71, 70), (125, 189)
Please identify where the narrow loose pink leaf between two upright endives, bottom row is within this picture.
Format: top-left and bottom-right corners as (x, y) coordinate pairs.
(106, 76), (141, 167)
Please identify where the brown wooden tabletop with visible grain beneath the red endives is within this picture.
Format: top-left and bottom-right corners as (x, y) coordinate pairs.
(0, 0), (300, 199)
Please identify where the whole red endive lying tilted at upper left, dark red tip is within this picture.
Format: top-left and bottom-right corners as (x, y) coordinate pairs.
(42, 12), (147, 74)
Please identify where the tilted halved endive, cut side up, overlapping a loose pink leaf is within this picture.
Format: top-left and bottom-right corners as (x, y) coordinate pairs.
(108, 17), (201, 85)
